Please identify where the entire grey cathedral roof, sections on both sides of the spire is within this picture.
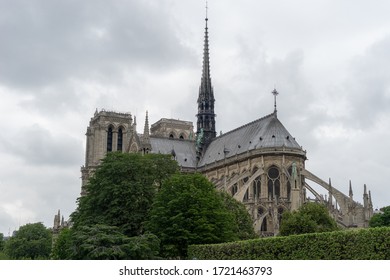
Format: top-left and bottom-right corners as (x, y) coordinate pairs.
(150, 114), (302, 168)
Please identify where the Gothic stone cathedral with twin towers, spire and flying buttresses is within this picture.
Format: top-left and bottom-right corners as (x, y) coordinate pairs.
(81, 14), (373, 236)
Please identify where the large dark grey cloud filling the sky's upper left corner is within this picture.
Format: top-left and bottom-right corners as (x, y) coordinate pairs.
(0, 0), (193, 87)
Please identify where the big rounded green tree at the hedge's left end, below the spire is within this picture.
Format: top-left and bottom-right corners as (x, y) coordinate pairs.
(146, 174), (238, 258)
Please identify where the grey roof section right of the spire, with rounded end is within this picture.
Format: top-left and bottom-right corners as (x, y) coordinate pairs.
(199, 113), (302, 166)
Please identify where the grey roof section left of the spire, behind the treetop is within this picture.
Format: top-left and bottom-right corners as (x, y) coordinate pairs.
(150, 136), (196, 168)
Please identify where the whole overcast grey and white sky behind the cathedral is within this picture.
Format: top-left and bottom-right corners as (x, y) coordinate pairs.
(0, 0), (390, 235)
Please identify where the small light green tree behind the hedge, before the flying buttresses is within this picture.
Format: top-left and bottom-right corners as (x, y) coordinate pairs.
(280, 203), (338, 235)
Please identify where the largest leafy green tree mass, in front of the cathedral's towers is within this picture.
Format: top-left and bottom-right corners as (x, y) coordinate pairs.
(58, 152), (178, 260)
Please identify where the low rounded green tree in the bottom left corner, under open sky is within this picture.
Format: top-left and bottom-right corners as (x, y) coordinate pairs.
(5, 223), (52, 260)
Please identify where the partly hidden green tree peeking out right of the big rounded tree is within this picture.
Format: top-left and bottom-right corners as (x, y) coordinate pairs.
(219, 191), (257, 240)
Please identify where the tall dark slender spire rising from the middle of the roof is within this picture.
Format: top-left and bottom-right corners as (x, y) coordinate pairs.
(196, 6), (217, 149)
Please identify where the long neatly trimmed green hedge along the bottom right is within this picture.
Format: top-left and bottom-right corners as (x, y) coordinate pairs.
(188, 227), (390, 260)
